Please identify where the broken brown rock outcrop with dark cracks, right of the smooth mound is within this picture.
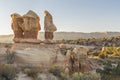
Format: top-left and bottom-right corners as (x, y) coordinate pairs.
(66, 47), (93, 73)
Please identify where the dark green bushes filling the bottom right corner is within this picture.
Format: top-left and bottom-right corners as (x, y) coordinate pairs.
(96, 61), (120, 80)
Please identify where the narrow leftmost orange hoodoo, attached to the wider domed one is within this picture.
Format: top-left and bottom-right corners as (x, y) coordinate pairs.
(11, 13), (23, 38)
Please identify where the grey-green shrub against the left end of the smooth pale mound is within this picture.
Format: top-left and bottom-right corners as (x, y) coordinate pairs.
(4, 50), (15, 64)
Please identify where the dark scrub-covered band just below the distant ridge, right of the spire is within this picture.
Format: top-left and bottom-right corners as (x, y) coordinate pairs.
(57, 36), (120, 47)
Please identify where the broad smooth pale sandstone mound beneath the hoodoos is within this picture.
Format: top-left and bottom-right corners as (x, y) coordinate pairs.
(13, 43), (65, 68)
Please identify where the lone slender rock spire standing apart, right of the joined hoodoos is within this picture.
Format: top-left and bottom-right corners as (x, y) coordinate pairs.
(44, 10), (57, 40)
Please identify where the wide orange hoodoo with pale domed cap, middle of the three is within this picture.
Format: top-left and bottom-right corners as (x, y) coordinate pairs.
(23, 10), (41, 39)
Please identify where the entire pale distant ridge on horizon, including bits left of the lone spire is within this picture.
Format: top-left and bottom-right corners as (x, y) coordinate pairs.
(0, 32), (120, 43)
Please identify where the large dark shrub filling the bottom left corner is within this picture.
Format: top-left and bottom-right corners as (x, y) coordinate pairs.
(0, 64), (18, 80)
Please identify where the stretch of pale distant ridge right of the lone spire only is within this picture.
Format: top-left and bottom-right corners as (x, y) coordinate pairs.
(55, 32), (120, 40)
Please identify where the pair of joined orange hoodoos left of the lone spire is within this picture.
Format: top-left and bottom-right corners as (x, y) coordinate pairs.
(11, 10), (41, 42)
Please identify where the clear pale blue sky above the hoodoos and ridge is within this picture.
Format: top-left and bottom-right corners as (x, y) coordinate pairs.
(0, 0), (120, 35)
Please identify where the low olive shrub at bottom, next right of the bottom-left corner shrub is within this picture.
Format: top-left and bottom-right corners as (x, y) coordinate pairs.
(22, 66), (41, 79)
